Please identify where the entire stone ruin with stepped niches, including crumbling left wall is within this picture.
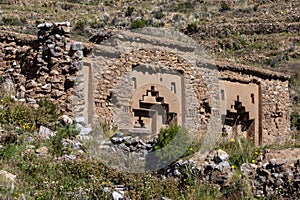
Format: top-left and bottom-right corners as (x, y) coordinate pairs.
(0, 23), (291, 145)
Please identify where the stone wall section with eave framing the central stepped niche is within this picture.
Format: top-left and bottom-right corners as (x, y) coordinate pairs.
(84, 28), (221, 143)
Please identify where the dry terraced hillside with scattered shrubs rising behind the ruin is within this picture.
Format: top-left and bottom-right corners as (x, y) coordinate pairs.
(0, 0), (300, 70)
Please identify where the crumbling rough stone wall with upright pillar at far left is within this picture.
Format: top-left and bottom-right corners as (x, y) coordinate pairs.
(0, 22), (83, 115)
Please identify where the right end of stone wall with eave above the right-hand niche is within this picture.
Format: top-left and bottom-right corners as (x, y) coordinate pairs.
(219, 66), (291, 145)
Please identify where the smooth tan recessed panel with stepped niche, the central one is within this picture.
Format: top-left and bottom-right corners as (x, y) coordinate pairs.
(130, 66), (182, 133)
